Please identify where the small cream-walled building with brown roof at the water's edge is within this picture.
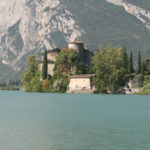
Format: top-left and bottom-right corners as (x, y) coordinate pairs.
(67, 74), (95, 93)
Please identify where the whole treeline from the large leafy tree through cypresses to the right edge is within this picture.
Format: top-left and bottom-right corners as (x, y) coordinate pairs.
(93, 47), (150, 93)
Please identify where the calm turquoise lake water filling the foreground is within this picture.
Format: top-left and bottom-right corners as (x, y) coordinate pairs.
(0, 91), (150, 150)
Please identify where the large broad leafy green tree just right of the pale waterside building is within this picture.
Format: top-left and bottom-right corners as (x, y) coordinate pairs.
(93, 47), (126, 93)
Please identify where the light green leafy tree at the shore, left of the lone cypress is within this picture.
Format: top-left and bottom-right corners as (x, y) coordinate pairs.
(22, 55), (41, 92)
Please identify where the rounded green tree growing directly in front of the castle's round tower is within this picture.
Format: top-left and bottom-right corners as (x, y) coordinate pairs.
(56, 48), (79, 77)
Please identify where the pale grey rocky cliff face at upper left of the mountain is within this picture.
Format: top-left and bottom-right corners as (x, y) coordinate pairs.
(0, 0), (84, 71)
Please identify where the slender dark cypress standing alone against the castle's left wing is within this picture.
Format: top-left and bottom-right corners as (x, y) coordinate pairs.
(42, 50), (48, 80)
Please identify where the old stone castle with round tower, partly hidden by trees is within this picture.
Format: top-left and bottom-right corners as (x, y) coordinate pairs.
(40, 40), (93, 76)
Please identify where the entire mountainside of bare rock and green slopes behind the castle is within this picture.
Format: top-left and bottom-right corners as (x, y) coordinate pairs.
(0, 0), (150, 80)
